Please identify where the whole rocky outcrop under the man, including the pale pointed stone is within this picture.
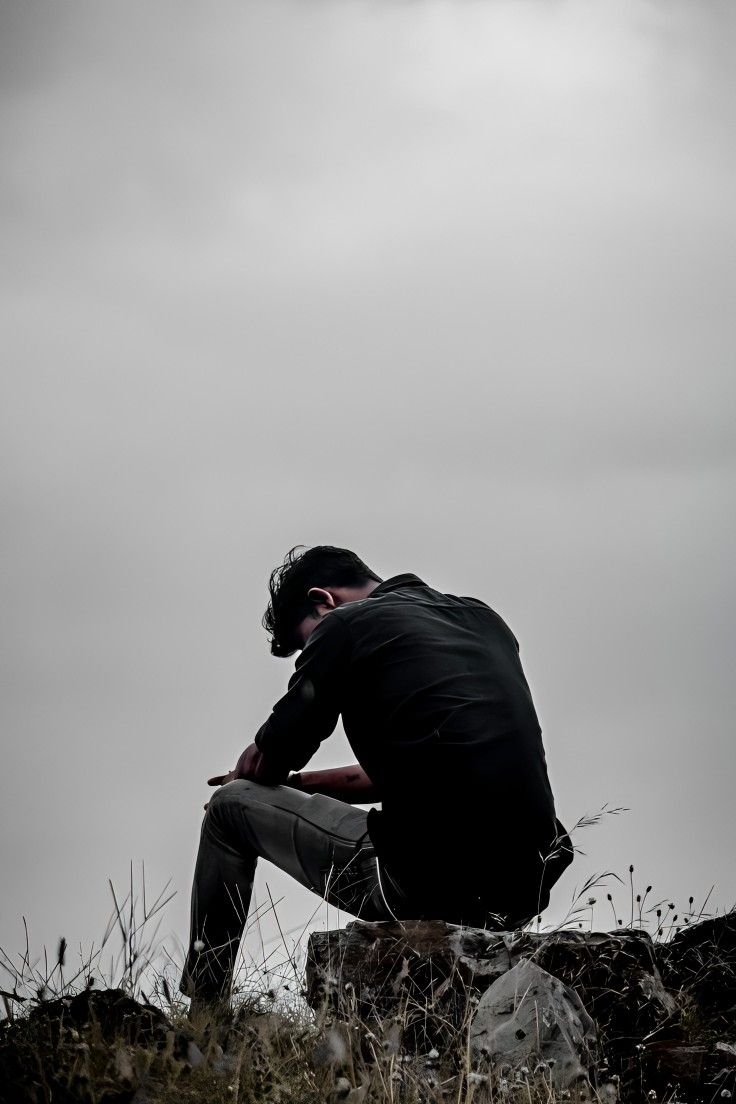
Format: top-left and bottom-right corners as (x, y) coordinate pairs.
(307, 913), (736, 1100)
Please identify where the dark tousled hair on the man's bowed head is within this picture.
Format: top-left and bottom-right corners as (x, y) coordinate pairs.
(263, 544), (382, 658)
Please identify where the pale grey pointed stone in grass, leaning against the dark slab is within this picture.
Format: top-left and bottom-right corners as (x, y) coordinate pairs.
(470, 958), (599, 1091)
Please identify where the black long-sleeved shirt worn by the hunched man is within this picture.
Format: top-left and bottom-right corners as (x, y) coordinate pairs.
(256, 574), (572, 923)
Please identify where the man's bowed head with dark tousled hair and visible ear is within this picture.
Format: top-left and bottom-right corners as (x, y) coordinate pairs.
(263, 544), (382, 657)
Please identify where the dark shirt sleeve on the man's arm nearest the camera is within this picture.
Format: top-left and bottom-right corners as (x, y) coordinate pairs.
(256, 613), (351, 771)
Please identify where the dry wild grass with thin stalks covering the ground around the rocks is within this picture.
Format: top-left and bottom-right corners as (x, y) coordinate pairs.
(0, 830), (732, 1104)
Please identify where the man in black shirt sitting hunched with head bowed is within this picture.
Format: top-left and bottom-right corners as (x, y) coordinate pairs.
(181, 545), (573, 1000)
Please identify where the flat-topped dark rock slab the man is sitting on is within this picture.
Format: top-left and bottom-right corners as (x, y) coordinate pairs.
(307, 921), (676, 1050)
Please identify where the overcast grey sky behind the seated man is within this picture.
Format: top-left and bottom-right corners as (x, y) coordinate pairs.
(0, 0), (736, 984)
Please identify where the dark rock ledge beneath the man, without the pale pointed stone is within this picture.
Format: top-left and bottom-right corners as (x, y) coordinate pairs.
(307, 913), (736, 1101)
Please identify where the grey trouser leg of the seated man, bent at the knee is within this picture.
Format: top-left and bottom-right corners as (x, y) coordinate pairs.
(182, 779), (396, 998)
